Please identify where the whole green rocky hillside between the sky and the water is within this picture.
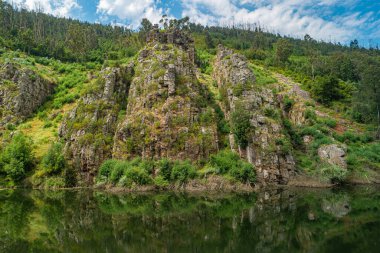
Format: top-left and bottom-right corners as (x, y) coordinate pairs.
(0, 5), (380, 190)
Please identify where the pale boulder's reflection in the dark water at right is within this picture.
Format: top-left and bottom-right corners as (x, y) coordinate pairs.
(322, 195), (351, 218)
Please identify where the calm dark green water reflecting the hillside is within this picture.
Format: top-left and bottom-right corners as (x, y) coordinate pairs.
(0, 187), (380, 253)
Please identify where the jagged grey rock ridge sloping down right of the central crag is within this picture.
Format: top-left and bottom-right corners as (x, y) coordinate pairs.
(213, 46), (294, 183)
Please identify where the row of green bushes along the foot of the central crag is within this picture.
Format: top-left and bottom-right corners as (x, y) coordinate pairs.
(96, 150), (256, 188)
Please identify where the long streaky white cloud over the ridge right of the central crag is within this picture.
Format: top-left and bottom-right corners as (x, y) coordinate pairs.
(182, 0), (371, 41)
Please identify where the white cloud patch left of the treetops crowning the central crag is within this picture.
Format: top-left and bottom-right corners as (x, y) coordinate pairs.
(97, 0), (164, 27)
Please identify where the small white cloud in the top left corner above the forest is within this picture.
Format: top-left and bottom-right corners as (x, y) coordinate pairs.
(7, 0), (81, 17)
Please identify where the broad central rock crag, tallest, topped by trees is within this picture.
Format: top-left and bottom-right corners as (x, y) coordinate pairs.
(113, 30), (218, 160)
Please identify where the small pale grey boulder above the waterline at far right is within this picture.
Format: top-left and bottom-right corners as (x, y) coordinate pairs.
(318, 144), (347, 169)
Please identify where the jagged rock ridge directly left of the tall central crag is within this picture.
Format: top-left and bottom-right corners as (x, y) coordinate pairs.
(59, 65), (133, 184)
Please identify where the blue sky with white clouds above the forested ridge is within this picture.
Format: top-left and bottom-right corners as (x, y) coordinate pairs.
(6, 0), (380, 47)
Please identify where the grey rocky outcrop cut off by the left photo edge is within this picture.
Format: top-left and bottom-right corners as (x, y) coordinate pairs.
(0, 63), (54, 126)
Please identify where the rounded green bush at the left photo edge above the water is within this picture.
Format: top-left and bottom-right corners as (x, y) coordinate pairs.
(0, 133), (34, 182)
